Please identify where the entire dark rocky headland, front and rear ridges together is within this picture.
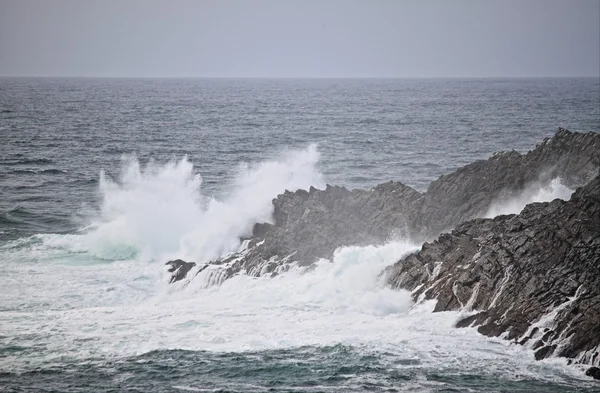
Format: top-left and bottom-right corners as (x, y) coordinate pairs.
(167, 128), (600, 375)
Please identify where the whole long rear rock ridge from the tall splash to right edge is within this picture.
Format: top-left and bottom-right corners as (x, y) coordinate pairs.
(174, 129), (600, 283)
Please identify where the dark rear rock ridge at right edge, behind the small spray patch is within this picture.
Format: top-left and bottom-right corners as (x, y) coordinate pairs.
(411, 128), (600, 240)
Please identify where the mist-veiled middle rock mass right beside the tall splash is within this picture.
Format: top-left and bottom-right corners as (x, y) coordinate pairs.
(220, 182), (420, 275)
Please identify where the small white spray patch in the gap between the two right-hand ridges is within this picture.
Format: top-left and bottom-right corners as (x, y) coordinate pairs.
(484, 178), (573, 218)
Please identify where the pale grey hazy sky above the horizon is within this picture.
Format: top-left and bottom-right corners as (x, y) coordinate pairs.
(0, 0), (600, 78)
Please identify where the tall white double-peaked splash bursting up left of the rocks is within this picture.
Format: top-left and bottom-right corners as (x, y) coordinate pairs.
(53, 145), (323, 262)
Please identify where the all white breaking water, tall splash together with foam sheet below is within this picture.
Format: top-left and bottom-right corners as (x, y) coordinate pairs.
(0, 155), (592, 388)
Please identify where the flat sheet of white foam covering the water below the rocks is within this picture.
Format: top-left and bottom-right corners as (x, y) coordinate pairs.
(0, 234), (578, 379)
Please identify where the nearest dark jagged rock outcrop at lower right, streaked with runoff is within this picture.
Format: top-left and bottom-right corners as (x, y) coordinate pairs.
(385, 175), (600, 366)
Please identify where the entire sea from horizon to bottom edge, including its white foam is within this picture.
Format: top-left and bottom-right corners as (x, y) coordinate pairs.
(0, 78), (600, 392)
